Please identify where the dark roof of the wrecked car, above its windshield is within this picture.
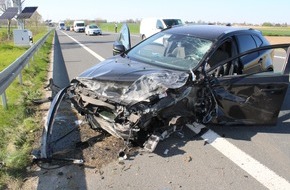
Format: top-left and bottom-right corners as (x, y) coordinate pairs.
(164, 25), (261, 41)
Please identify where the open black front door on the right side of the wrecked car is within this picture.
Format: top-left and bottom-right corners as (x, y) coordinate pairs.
(208, 44), (290, 125)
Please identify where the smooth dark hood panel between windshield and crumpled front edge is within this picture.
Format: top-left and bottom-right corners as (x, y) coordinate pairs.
(77, 55), (172, 82)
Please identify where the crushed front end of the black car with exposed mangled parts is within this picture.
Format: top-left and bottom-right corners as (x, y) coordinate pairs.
(67, 72), (216, 151)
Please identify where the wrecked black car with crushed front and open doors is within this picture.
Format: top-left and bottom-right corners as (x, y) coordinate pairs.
(42, 25), (290, 158)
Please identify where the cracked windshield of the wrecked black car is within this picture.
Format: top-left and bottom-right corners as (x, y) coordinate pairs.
(128, 32), (212, 70)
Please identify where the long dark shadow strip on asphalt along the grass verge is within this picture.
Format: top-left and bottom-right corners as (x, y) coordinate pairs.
(36, 30), (86, 190)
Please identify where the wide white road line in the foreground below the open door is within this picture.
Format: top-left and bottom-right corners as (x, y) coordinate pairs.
(188, 124), (290, 190)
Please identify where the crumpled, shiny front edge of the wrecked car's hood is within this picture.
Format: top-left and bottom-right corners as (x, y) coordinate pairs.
(76, 71), (189, 104)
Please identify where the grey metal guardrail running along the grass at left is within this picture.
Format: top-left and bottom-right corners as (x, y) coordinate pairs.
(0, 30), (53, 109)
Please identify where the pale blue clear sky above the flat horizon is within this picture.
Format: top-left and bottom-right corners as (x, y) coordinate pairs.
(23, 0), (290, 24)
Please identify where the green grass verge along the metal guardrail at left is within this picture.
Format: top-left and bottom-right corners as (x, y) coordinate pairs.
(0, 32), (53, 189)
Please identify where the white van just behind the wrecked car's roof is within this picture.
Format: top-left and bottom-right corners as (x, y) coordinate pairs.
(140, 18), (183, 40)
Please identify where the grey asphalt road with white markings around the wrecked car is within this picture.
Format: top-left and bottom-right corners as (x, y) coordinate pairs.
(34, 31), (290, 190)
